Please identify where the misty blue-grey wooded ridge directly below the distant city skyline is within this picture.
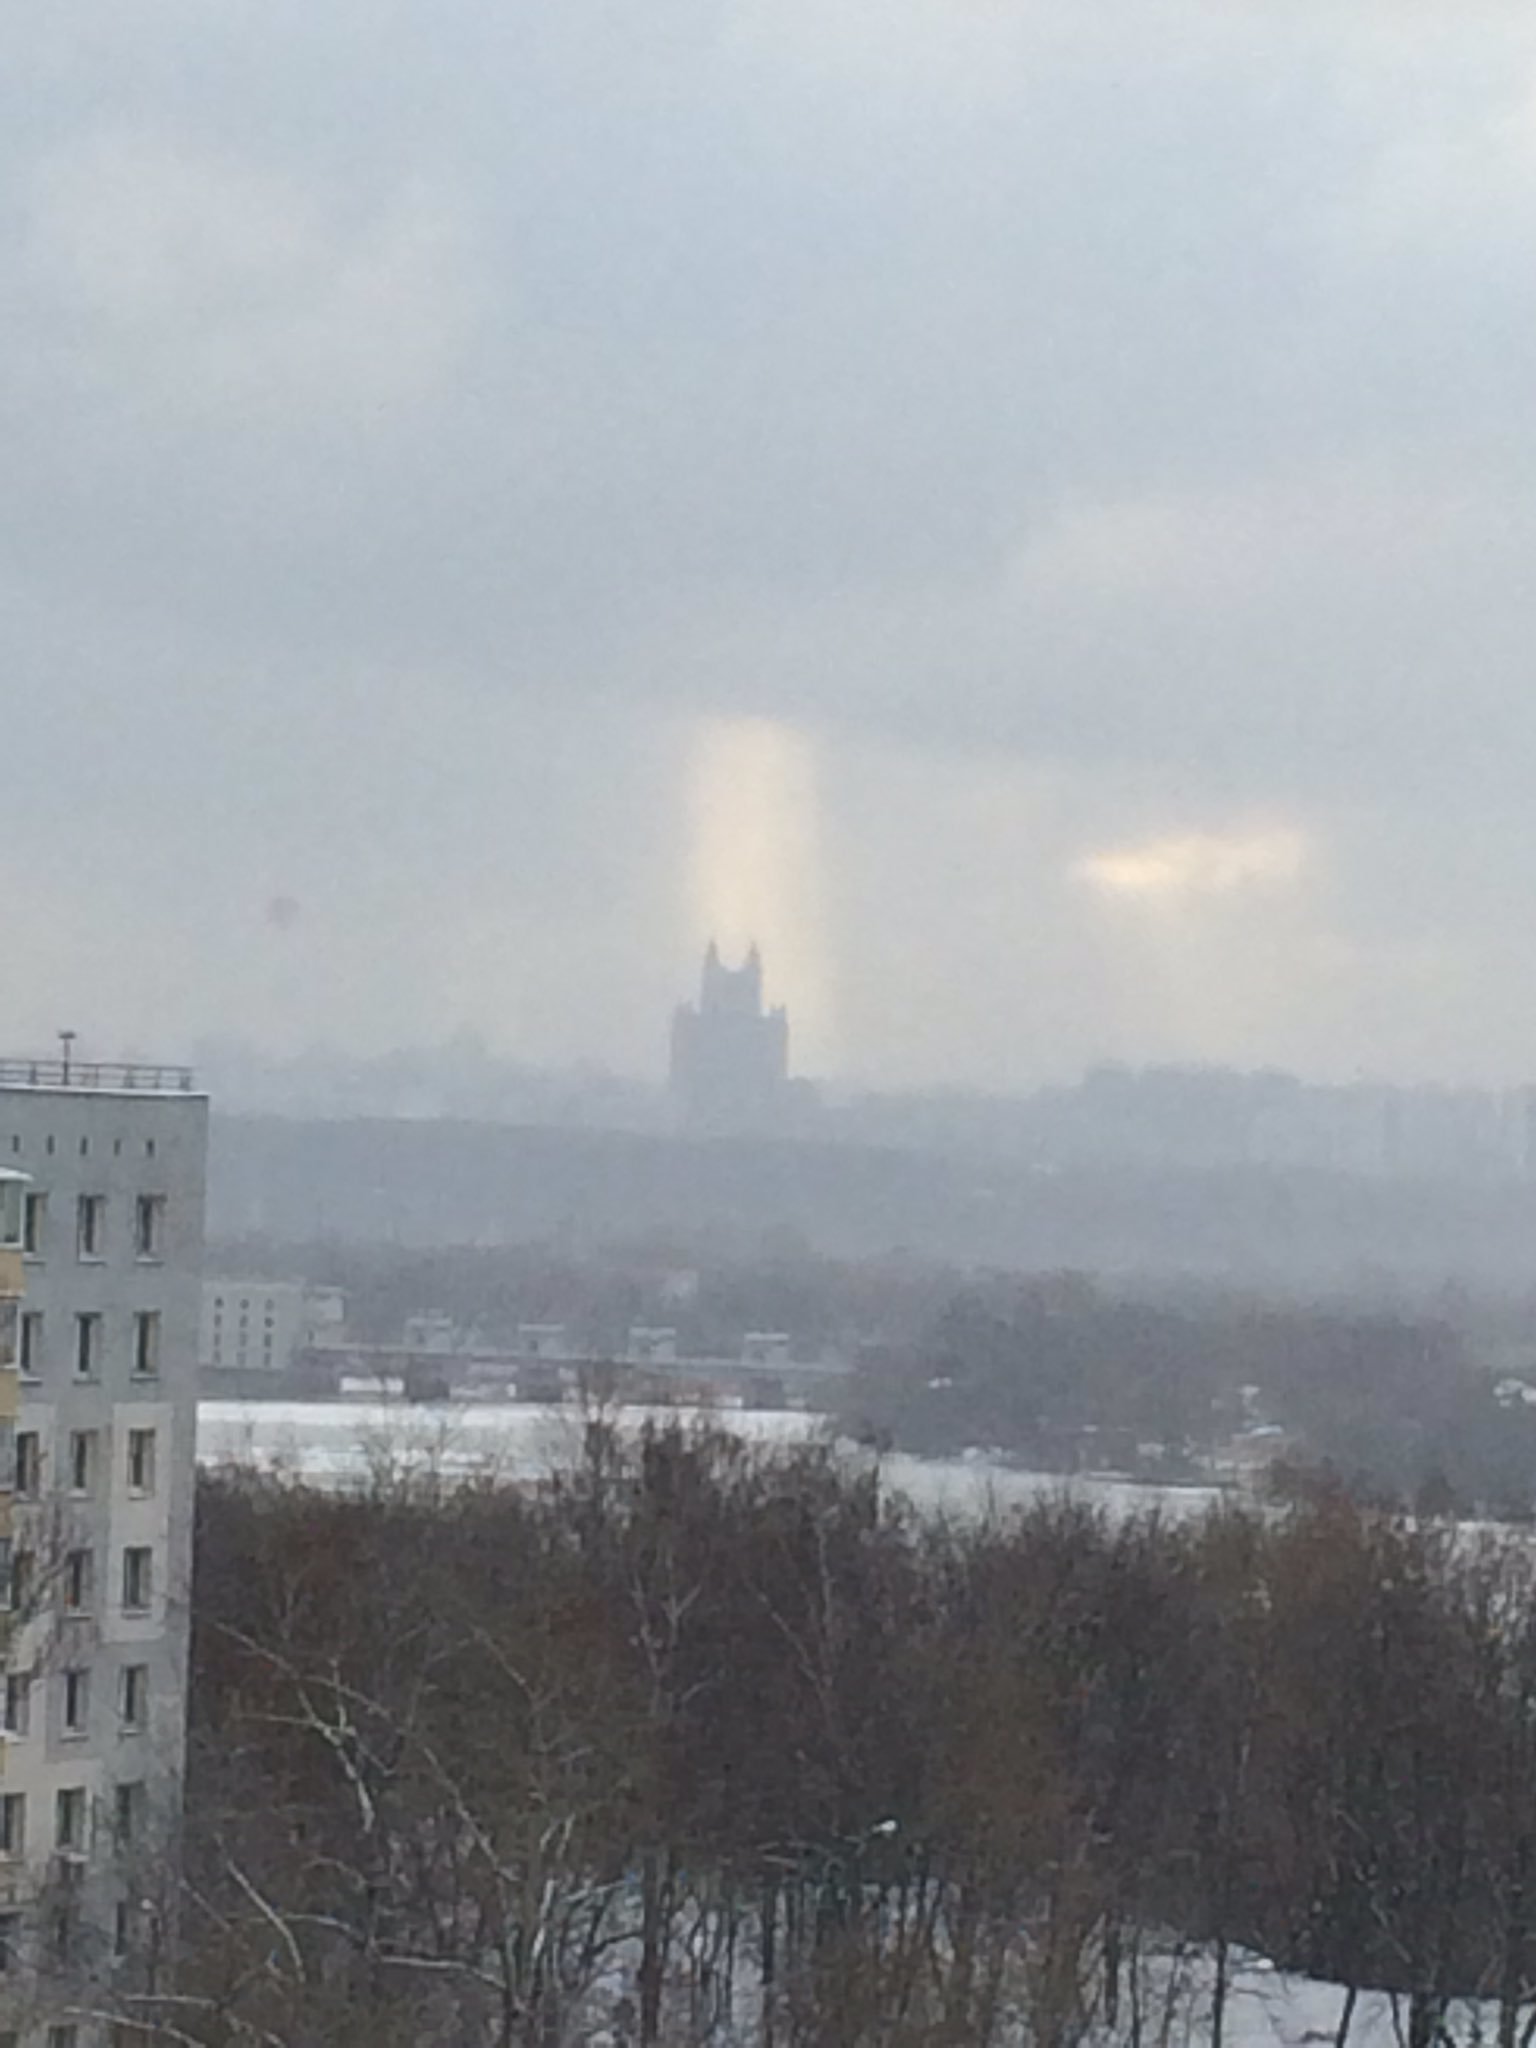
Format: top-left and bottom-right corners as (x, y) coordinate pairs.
(209, 1110), (1536, 1290)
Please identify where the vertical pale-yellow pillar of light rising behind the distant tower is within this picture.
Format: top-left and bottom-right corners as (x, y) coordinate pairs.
(688, 719), (834, 1073)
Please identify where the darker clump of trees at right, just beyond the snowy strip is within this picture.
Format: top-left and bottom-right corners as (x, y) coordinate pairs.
(844, 1274), (1536, 1520)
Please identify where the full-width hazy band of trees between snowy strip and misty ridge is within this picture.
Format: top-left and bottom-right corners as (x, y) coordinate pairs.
(209, 1235), (1536, 1520)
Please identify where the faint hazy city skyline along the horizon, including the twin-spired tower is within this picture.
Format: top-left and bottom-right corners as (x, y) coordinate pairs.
(195, 1007), (1536, 1180)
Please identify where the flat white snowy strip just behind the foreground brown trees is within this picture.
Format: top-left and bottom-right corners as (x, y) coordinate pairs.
(197, 1401), (1217, 1513)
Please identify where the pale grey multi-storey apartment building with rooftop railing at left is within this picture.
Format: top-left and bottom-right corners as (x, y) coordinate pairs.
(0, 1061), (207, 2048)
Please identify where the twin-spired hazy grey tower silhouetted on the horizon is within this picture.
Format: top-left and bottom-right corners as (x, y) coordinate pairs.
(672, 940), (788, 1133)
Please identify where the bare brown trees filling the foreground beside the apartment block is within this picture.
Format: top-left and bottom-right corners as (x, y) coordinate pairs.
(108, 1419), (1536, 2048)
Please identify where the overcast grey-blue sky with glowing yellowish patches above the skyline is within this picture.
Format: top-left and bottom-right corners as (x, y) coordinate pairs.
(0, 0), (1536, 1085)
